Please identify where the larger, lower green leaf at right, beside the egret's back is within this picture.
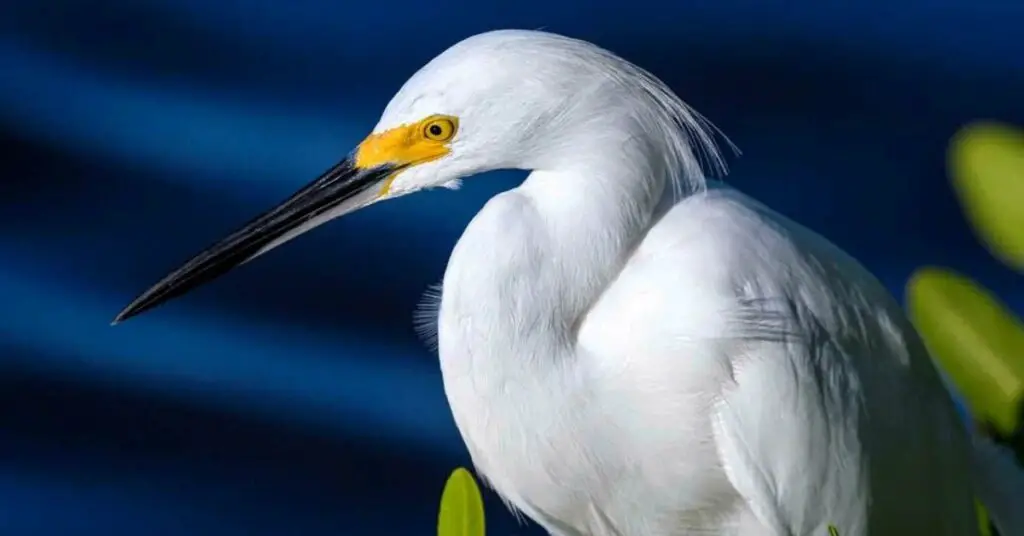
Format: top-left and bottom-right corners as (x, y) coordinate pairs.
(906, 267), (1024, 434)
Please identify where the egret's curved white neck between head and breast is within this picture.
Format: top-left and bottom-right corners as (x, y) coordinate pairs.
(439, 147), (666, 373)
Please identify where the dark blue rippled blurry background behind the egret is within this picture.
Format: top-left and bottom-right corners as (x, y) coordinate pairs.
(0, 0), (1024, 536)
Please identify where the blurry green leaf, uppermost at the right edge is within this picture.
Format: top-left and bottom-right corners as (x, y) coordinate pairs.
(949, 123), (1024, 272)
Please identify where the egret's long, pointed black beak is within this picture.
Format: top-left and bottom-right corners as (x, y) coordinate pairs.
(112, 158), (399, 325)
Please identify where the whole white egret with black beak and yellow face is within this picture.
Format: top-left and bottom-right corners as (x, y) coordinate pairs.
(115, 31), (1021, 536)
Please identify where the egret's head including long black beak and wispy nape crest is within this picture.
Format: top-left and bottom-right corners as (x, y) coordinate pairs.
(114, 30), (709, 324)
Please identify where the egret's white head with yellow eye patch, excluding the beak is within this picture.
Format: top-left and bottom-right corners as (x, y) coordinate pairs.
(353, 30), (626, 195)
